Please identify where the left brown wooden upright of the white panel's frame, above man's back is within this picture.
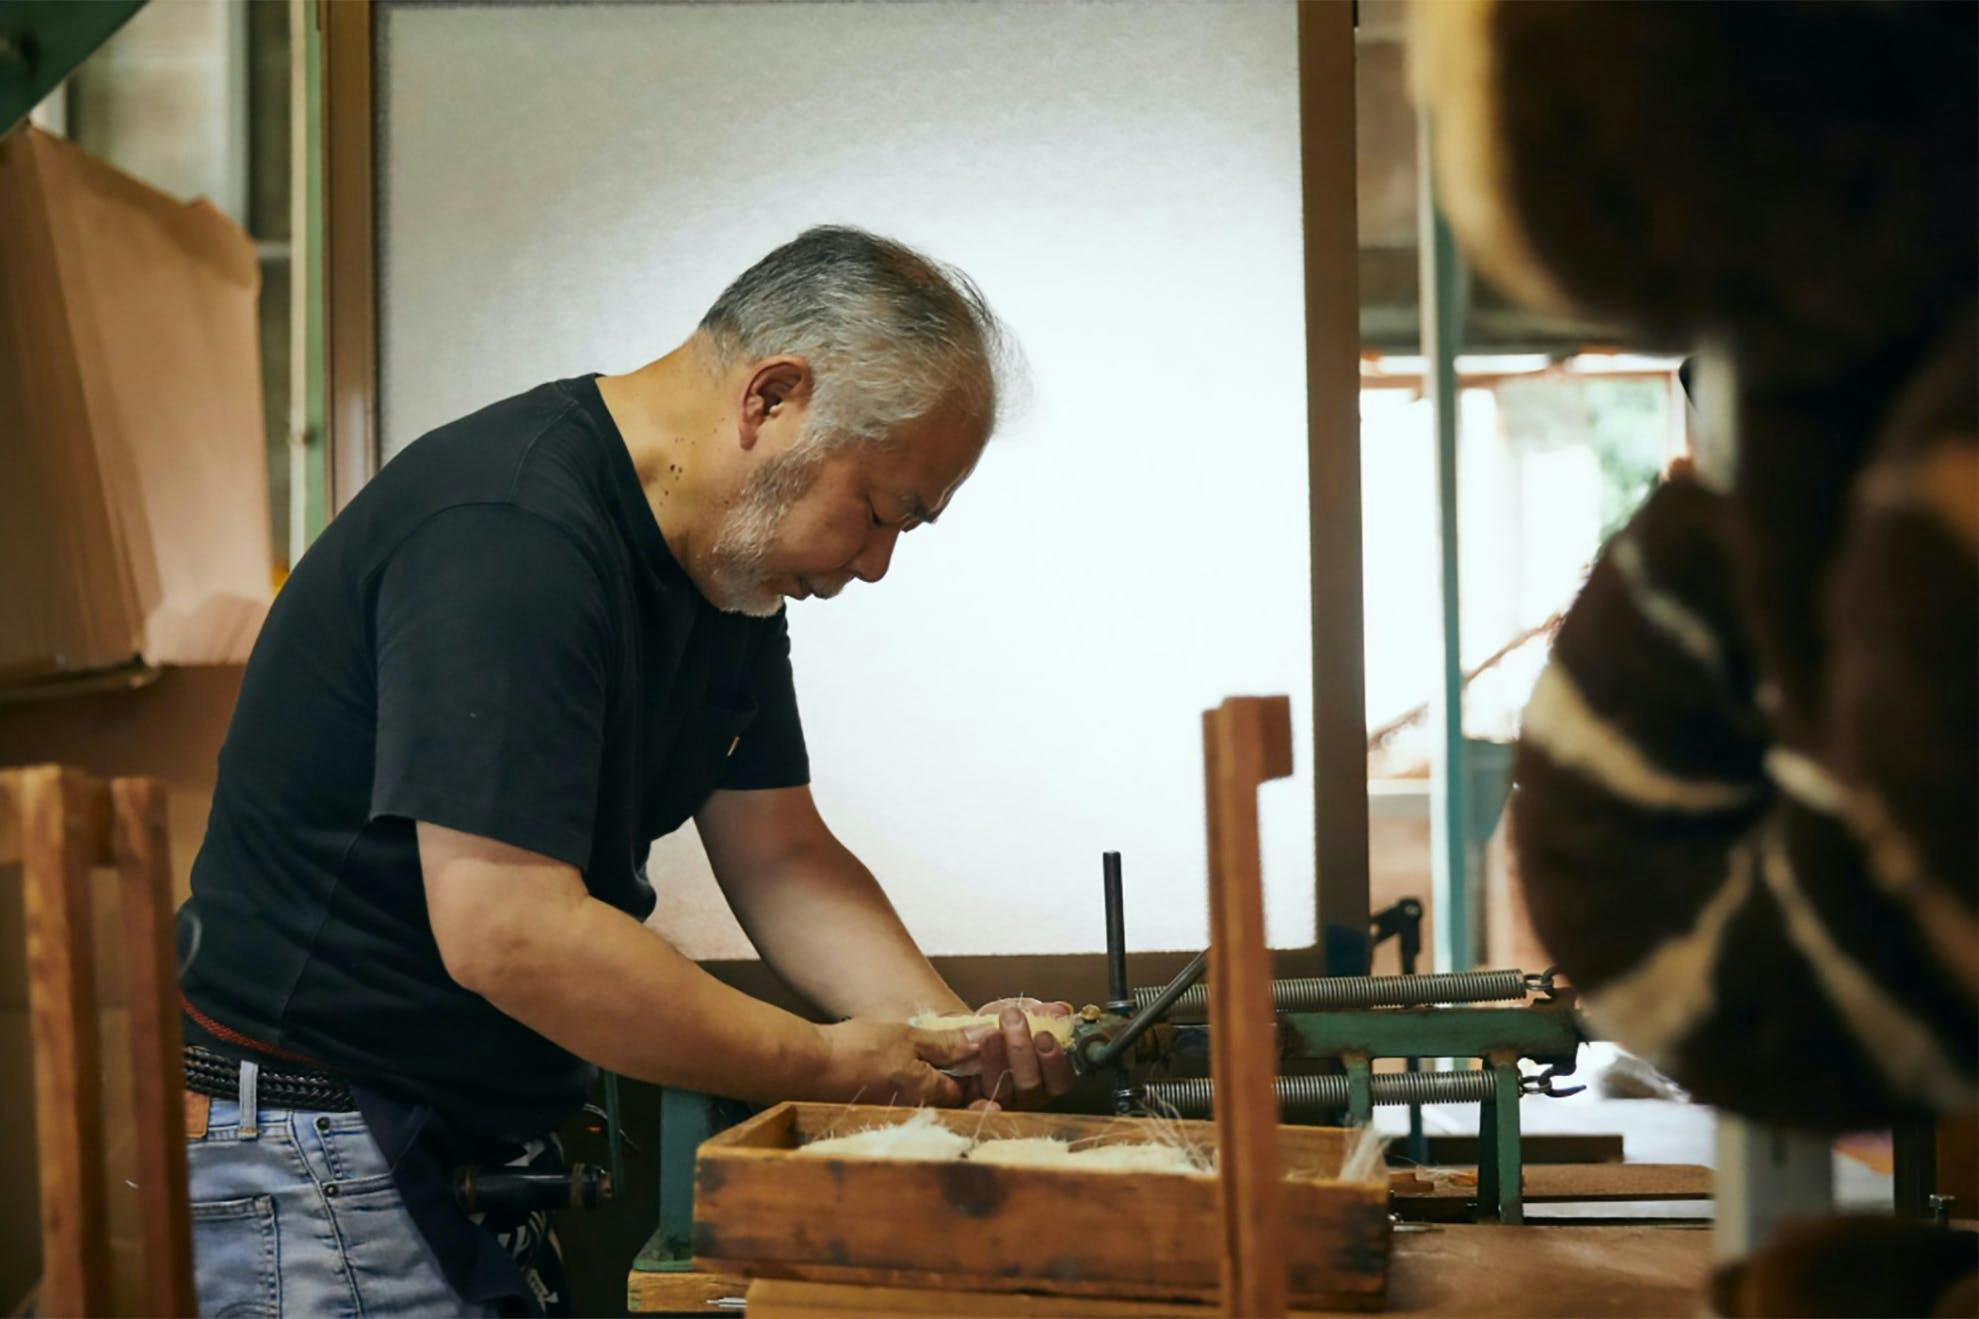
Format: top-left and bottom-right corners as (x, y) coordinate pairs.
(317, 0), (380, 517)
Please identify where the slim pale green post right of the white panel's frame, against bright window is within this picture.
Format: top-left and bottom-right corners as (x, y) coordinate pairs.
(1417, 115), (1476, 970)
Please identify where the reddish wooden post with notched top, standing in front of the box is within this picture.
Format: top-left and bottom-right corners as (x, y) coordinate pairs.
(1203, 697), (1292, 1315)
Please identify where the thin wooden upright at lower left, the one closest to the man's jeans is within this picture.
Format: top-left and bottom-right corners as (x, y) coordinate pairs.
(111, 778), (196, 1315)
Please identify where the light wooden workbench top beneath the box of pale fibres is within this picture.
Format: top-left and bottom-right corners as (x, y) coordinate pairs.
(746, 1224), (1712, 1319)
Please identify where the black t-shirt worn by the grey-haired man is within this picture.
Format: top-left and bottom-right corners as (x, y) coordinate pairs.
(178, 378), (809, 1135)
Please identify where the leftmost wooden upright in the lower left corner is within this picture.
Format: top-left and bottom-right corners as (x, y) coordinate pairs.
(18, 766), (109, 1315)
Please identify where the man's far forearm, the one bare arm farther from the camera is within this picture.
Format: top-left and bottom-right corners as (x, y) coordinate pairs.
(728, 840), (968, 1020)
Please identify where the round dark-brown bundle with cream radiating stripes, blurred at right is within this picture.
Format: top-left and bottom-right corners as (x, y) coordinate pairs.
(1512, 311), (1979, 1129)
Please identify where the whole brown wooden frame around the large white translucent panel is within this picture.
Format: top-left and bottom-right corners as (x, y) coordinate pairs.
(317, 0), (1367, 1006)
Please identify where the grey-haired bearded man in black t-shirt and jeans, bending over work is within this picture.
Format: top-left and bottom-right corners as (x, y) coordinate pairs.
(180, 228), (1071, 1313)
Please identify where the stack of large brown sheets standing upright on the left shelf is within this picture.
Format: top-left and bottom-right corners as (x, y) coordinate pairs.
(0, 127), (273, 683)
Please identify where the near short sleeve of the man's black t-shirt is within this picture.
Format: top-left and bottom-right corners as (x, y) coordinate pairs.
(370, 505), (613, 869)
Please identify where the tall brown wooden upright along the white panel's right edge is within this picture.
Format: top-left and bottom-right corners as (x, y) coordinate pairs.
(1298, 4), (1367, 974)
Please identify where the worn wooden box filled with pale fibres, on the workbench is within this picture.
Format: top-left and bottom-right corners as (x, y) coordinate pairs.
(695, 1103), (1389, 1309)
